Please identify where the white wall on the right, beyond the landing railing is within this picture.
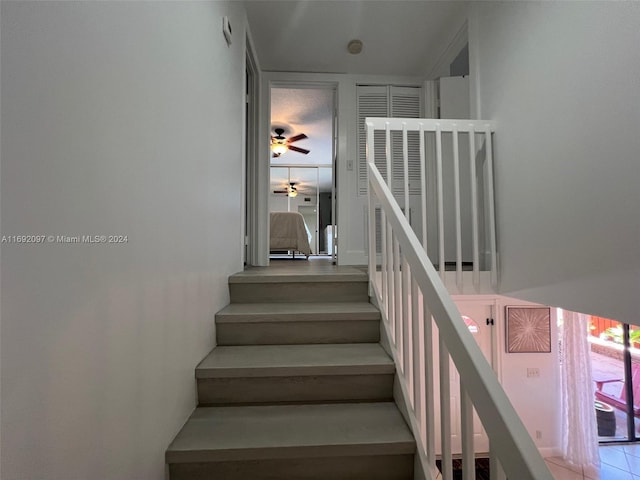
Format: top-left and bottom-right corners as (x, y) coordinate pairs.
(469, 2), (640, 323)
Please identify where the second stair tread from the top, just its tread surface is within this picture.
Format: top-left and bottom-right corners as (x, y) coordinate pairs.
(216, 302), (380, 323)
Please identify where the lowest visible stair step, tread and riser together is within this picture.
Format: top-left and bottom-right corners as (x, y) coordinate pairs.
(166, 402), (415, 480)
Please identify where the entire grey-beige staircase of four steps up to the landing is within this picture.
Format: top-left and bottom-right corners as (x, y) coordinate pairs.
(166, 262), (415, 480)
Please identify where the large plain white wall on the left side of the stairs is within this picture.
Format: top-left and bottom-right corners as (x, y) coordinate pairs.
(1, 2), (245, 480)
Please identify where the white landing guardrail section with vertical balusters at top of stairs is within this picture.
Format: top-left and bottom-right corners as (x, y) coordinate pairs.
(366, 118), (498, 293)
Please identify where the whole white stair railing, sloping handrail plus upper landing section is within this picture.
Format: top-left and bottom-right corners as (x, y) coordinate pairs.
(366, 118), (553, 480)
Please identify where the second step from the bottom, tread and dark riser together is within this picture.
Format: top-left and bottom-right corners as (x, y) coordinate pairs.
(196, 343), (395, 406)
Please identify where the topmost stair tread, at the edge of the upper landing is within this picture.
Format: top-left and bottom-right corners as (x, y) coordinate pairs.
(229, 266), (368, 283)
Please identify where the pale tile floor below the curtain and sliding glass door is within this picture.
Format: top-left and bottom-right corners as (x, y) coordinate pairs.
(545, 443), (640, 480)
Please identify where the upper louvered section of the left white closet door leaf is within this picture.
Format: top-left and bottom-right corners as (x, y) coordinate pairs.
(357, 86), (389, 195)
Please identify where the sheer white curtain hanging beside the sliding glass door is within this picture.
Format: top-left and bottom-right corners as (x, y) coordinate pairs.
(562, 310), (600, 466)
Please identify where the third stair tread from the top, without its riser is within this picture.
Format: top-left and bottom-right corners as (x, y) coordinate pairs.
(196, 343), (395, 378)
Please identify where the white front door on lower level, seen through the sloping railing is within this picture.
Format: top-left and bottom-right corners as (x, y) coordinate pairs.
(434, 301), (493, 454)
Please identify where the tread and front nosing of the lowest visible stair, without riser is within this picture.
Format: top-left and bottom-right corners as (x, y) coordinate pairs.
(166, 402), (415, 463)
